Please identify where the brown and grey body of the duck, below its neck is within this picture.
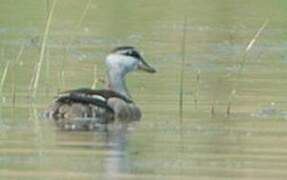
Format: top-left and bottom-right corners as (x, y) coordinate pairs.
(48, 88), (140, 130)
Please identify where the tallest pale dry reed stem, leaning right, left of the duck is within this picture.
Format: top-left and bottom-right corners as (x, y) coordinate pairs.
(33, 0), (57, 97)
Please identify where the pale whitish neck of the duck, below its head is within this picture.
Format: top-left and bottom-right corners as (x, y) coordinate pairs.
(107, 69), (131, 99)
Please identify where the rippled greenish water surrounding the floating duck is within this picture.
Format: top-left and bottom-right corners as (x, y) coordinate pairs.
(0, 0), (287, 180)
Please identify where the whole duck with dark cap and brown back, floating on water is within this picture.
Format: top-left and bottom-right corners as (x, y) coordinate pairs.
(47, 46), (156, 130)
